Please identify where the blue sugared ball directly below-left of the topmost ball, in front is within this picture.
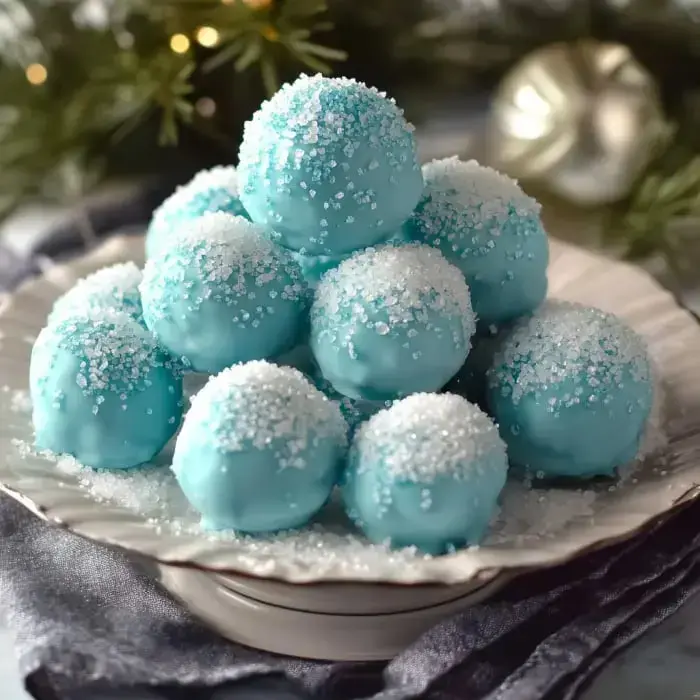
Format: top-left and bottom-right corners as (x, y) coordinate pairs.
(141, 212), (308, 374)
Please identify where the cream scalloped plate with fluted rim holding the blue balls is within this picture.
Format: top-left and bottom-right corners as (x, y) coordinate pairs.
(0, 238), (700, 588)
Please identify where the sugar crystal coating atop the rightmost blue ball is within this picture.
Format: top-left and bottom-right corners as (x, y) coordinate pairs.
(490, 300), (651, 407)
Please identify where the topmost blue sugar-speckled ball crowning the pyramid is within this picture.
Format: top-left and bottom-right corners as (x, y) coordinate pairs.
(238, 75), (423, 257)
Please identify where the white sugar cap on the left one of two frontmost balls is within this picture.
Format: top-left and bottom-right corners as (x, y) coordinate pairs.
(181, 360), (347, 468)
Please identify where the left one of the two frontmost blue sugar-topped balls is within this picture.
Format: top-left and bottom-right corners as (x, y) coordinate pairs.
(172, 361), (347, 533)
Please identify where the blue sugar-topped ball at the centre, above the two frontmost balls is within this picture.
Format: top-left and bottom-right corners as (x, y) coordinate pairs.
(310, 244), (475, 401)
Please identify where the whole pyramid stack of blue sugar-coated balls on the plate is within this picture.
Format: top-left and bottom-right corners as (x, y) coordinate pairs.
(30, 76), (652, 554)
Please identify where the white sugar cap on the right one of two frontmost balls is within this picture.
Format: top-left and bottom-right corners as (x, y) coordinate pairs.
(353, 394), (506, 484)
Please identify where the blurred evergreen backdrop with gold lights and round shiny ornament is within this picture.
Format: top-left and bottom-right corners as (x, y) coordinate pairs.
(0, 0), (700, 290)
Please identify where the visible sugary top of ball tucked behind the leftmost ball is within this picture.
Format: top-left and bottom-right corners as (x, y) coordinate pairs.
(49, 262), (143, 323)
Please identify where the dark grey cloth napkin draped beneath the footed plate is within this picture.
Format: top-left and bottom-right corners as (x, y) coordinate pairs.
(0, 496), (700, 700)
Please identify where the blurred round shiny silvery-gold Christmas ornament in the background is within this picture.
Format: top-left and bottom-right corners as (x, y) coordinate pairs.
(492, 40), (668, 206)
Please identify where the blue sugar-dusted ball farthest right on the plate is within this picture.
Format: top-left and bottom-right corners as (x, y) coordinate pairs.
(487, 301), (653, 478)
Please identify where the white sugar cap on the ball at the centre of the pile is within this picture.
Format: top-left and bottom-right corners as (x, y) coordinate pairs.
(311, 244), (475, 339)
